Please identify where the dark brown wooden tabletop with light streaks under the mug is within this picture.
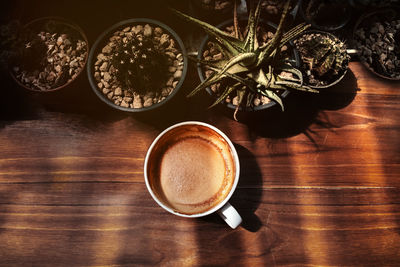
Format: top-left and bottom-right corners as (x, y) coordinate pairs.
(0, 1), (400, 266)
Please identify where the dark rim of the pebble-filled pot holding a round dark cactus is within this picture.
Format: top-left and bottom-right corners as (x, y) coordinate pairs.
(87, 18), (188, 113)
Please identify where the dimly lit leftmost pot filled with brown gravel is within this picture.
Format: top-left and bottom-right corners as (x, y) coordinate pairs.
(9, 17), (89, 92)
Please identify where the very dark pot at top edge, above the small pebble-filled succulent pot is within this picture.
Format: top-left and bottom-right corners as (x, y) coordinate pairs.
(299, 0), (352, 31)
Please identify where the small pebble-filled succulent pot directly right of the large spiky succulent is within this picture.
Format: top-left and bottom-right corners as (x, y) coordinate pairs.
(294, 30), (350, 89)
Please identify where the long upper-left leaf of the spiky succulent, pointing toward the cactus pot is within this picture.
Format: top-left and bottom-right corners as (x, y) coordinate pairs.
(171, 9), (244, 55)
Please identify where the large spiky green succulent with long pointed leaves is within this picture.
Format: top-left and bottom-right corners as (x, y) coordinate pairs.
(174, 0), (318, 119)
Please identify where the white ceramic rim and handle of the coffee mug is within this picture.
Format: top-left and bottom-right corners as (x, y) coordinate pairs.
(144, 121), (242, 229)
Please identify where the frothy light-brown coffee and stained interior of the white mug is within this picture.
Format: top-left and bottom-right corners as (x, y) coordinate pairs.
(148, 125), (235, 214)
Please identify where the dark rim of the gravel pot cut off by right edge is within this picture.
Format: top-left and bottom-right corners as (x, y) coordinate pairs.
(351, 6), (400, 81)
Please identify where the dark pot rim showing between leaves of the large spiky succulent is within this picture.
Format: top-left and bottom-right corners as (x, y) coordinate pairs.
(197, 18), (300, 112)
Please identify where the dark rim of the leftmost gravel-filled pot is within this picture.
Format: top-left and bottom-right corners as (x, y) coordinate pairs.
(9, 16), (90, 93)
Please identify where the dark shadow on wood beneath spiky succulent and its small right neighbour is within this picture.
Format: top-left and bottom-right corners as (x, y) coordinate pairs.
(243, 69), (358, 142)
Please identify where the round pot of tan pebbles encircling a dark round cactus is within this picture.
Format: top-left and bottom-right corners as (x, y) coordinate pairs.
(87, 18), (187, 112)
